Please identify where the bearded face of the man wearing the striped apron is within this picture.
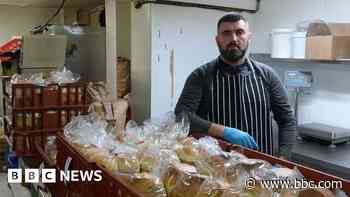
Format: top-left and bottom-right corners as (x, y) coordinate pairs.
(216, 20), (251, 62)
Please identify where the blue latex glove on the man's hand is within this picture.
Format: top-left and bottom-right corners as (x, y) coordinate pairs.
(223, 127), (258, 150)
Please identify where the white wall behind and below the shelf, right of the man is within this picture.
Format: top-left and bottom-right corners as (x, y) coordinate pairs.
(253, 0), (350, 128)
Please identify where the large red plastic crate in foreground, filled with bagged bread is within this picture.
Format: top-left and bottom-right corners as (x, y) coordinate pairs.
(57, 134), (350, 197)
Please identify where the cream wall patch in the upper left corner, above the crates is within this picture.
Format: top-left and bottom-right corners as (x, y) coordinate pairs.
(0, 6), (63, 44)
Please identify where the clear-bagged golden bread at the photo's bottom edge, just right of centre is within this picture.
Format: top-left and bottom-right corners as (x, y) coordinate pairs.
(162, 163), (208, 197)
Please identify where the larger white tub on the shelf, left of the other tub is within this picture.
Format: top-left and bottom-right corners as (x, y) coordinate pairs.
(271, 29), (294, 58)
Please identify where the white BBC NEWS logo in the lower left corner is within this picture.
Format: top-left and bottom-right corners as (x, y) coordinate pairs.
(7, 169), (102, 183)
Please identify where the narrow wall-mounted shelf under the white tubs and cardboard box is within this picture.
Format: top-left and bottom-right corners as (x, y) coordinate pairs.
(251, 53), (350, 64)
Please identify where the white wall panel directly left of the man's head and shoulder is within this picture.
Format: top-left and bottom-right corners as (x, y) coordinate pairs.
(151, 5), (222, 116)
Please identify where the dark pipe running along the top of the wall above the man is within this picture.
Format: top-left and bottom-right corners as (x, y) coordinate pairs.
(135, 0), (261, 13)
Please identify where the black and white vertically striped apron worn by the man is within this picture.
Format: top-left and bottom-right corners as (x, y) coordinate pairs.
(207, 60), (274, 154)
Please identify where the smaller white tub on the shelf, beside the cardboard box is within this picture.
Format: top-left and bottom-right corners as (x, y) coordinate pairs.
(292, 32), (306, 59)
